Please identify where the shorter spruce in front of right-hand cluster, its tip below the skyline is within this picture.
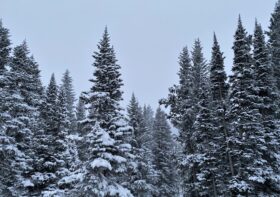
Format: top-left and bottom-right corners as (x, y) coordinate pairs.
(191, 84), (219, 197)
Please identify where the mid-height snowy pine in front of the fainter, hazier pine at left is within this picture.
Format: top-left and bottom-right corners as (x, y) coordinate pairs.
(32, 74), (73, 196)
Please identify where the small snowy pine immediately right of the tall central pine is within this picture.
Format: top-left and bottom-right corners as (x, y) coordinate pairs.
(127, 94), (154, 197)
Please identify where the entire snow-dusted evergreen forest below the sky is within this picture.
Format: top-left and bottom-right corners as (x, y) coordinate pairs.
(0, 1), (280, 197)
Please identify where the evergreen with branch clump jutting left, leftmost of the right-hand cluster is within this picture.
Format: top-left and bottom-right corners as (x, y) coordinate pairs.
(161, 45), (195, 196)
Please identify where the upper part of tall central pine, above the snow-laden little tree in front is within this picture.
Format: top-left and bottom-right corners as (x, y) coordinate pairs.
(84, 28), (123, 132)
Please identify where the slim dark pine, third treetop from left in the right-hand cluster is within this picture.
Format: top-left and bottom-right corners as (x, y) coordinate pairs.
(209, 34), (229, 195)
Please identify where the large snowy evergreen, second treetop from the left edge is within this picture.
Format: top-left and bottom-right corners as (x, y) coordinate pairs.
(4, 41), (40, 196)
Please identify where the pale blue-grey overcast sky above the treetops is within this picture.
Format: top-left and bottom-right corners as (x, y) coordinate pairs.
(0, 0), (276, 107)
